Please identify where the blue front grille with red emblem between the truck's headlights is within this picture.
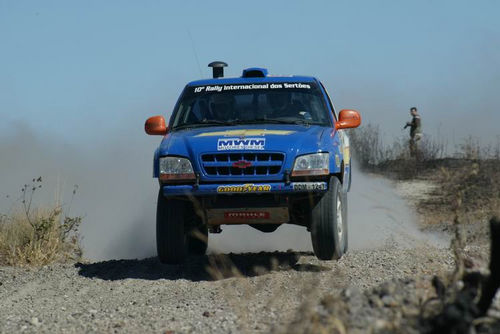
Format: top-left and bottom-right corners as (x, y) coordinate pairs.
(201, 153), (285, 176)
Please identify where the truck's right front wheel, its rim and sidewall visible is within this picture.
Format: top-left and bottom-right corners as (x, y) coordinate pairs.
(311, 177), (347, 260)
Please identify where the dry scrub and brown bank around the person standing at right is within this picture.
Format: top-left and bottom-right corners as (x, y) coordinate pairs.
(350, 124), (500, 220)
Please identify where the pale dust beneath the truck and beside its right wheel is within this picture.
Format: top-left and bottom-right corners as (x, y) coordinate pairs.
(209, 164), (443, 253)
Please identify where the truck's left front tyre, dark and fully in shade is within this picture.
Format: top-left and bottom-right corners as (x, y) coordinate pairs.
(156, 189), (187, 264)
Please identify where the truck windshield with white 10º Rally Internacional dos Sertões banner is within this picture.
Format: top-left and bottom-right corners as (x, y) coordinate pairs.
(172, 82), (331, 130)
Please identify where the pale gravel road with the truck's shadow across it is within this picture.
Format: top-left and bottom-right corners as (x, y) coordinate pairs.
(0, 176), (484, 333)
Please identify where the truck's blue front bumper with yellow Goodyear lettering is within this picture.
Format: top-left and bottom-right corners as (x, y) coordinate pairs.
(162, 181), (328, 197)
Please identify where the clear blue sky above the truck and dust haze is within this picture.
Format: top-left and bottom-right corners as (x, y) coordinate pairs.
(0, 0), (500, 144)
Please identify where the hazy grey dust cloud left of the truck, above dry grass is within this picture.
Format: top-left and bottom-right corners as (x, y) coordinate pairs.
(0, 124), (157, 260)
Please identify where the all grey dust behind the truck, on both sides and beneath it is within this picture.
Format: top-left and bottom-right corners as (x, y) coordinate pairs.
(0, 124), (442, 260)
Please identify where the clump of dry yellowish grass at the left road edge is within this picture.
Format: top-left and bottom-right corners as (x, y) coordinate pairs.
(0, 177), (82, 266)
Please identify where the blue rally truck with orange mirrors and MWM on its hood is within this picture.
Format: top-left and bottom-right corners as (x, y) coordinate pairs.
(145, 62), (361, 264)
